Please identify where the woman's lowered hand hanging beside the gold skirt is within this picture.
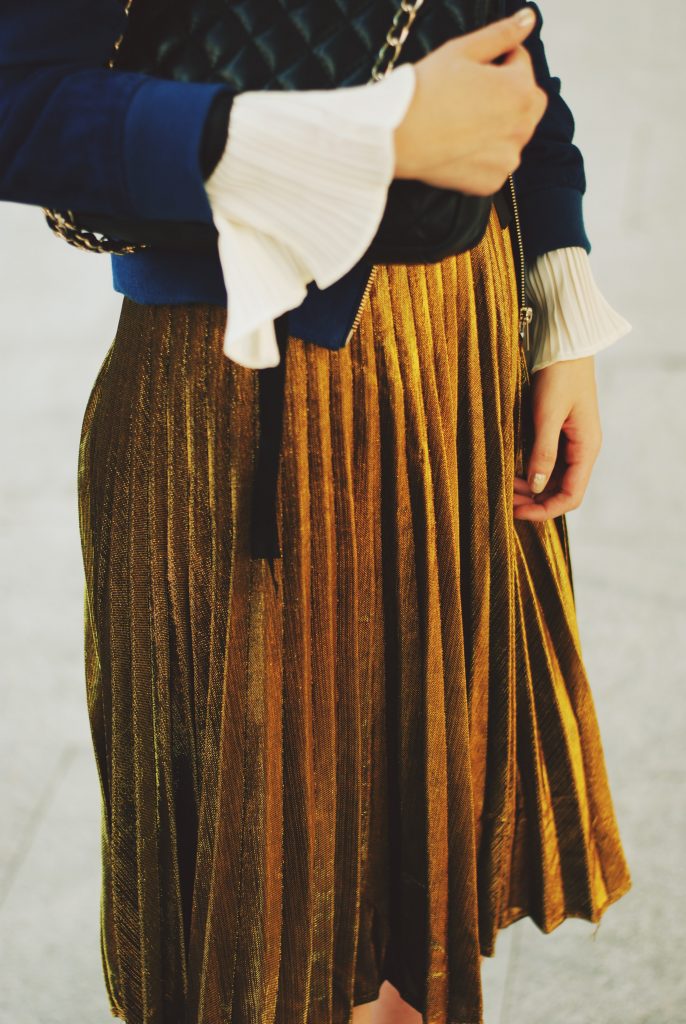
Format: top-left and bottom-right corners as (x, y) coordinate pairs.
(514, 355), (602, 522)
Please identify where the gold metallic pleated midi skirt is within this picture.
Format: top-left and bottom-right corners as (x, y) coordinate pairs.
(79, 208), (631, 1024)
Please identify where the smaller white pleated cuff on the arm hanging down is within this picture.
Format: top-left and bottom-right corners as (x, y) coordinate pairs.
(526, 246), (632, 373)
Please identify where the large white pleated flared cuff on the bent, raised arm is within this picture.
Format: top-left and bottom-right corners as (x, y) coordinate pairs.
(205, 63), (416, 369)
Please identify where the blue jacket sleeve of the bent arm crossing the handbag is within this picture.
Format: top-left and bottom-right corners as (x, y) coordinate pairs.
(0, 0), (235, 221)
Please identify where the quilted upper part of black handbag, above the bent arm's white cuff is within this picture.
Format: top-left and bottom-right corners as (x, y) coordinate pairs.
(117, 0), (504, 91)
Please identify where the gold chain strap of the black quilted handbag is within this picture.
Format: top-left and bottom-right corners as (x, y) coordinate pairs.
(43, 0), (424, 256)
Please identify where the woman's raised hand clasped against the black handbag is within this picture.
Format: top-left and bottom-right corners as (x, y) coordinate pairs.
(394, 7), (548, 196)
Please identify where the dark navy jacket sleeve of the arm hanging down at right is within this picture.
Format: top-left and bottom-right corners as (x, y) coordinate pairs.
(506, 0), (591, 263)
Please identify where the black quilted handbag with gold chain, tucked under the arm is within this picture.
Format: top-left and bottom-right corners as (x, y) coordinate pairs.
(45, 0), (503, 263)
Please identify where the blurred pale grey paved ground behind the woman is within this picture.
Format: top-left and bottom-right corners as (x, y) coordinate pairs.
(0, 0), (686, 1024)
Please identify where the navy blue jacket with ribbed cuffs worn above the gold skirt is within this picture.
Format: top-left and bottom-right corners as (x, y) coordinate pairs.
(0, 0), (591, 304)
